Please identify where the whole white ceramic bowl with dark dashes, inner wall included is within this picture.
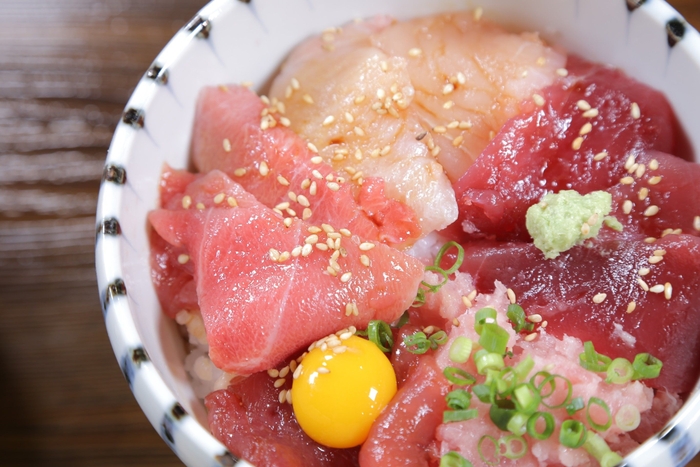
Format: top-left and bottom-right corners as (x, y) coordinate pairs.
(96, 0), (700, 466)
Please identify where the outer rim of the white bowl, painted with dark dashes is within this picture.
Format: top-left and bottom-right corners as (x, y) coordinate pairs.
(95, 0), (700, 467)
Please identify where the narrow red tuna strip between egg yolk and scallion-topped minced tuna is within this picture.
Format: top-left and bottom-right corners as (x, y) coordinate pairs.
(360, 355), (450, 467)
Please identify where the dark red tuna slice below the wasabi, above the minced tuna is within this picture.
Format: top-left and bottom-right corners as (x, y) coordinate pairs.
(460, 235), (700, 393)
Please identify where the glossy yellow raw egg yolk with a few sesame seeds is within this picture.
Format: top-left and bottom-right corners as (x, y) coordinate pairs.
(292, 336), (396, 448)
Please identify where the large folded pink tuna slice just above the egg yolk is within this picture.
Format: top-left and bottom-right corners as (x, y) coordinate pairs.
(149, 171), (423, 374)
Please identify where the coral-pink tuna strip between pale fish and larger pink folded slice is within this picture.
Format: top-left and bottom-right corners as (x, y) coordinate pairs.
(192, 86), (420, 250)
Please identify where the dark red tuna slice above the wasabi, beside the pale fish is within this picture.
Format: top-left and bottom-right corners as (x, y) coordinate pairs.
(455, 57), (676, 240)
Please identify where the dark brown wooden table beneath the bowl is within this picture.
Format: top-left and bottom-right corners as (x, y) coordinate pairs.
(0, 0), (700, 467)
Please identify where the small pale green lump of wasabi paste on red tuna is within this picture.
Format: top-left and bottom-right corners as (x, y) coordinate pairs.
(525, 190), (622, 259)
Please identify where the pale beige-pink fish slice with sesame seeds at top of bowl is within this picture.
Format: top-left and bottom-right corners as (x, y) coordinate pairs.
(270, 12), (565, 233)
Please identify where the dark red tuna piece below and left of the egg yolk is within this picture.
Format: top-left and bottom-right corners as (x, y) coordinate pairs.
(205, 373), (358, 467)
